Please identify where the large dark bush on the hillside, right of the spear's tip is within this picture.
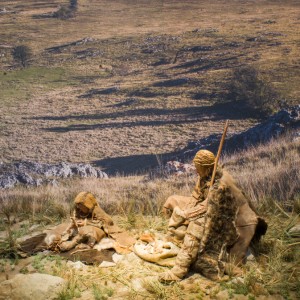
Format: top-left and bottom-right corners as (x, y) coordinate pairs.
(226, 66), (279, 114)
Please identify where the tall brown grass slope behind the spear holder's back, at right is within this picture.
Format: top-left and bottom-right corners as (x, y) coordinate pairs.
(224, 132), (300, 213)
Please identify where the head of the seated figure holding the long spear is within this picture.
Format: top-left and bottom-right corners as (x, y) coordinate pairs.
(193, 150), (216, 177)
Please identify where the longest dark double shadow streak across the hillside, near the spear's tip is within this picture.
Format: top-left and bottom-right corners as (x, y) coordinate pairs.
(36, 102), (258, 133)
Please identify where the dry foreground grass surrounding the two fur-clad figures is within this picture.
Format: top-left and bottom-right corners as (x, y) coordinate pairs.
(0, 135), (300, 299)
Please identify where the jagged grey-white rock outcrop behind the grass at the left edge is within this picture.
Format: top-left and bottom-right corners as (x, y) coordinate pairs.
(0, 161), (108, 189)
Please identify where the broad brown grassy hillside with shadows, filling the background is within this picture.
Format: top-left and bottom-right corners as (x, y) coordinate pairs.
(0, 0), (300, 172)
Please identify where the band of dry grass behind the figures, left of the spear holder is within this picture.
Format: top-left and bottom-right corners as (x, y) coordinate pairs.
(0, 172), (191, 238)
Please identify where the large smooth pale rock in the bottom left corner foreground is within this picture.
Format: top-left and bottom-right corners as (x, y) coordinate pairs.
(0, 273), (65, 300)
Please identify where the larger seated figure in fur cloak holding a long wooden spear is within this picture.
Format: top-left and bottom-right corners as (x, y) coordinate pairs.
(159, 150), (267, 282)
